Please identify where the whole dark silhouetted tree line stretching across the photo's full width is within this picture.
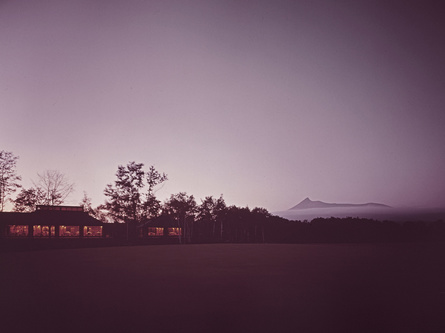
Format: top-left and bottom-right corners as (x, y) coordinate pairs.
(0, 151), (445, 243)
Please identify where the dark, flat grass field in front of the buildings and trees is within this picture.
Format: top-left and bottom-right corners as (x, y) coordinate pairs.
(0, 244), (445, 332)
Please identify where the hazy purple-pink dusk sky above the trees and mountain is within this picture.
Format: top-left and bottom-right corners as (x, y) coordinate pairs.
(0, 0), (445, 211)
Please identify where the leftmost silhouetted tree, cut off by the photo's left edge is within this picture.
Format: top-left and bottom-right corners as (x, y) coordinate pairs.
(0, 150), (21, 212)
